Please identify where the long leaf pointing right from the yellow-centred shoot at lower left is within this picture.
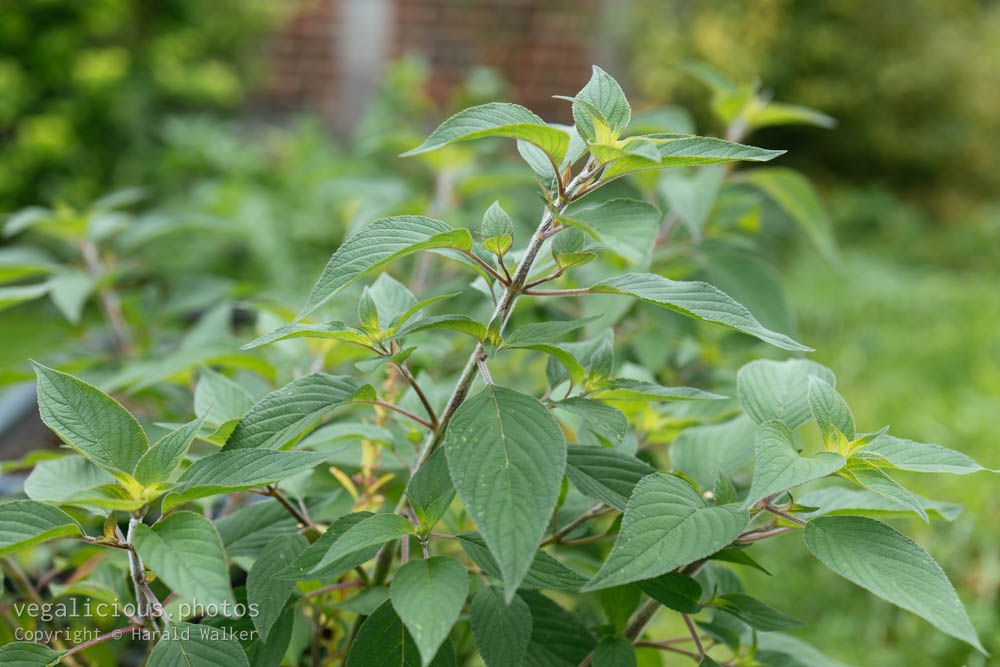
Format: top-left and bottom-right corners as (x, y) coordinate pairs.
(163, 449), (330, 512)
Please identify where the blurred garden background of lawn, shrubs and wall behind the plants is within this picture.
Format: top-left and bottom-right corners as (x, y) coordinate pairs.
(0, 0), (1000, 665)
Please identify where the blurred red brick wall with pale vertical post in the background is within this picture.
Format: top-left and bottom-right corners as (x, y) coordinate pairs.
(260, 0), (607, 127)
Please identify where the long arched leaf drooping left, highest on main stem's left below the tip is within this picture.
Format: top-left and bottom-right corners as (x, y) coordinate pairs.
(296, 215), (472, 319)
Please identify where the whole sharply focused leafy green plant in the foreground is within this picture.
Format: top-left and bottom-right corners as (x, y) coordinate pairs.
(0, 67), (983, 667)
